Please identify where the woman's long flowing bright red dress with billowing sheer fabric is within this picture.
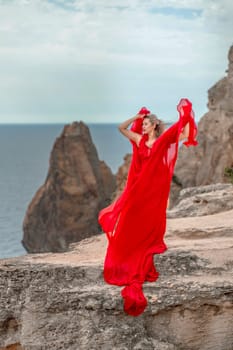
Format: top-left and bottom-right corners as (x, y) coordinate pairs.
(99, 99), (197, 316)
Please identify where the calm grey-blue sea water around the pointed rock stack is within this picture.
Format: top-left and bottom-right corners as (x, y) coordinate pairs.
(0, 124), (131, 258)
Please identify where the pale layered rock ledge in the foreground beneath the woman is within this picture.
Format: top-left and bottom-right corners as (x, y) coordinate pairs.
(0, 206), (233, 350)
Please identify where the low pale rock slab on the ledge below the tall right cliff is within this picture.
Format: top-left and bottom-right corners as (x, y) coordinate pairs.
(167, 184), (233, 218)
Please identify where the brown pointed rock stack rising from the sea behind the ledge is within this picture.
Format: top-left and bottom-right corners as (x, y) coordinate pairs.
(22, 122), (115, 253)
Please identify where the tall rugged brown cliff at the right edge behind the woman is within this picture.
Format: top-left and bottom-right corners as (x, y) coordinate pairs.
(175, 46), (233, 188)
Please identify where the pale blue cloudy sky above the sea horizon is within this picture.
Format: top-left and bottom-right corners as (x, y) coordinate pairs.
(0, 0), (233, 123)
